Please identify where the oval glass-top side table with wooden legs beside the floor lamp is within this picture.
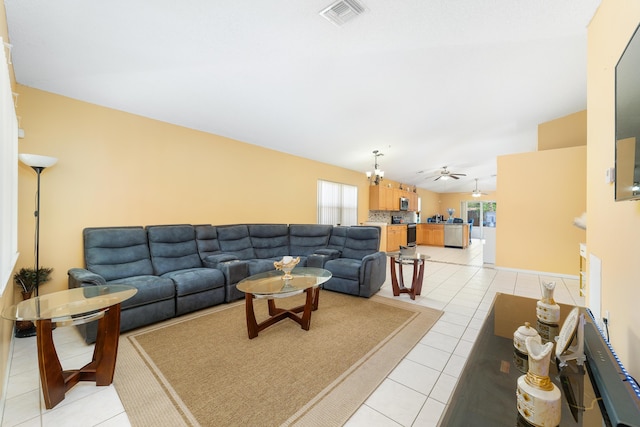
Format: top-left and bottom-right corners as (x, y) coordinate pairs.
(2, 285), (138, 409)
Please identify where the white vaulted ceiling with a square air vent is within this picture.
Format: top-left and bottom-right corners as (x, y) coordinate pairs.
(4, 0), (600, 192)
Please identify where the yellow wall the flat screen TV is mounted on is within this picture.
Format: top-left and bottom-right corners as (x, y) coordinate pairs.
(587, 0), (640, 378)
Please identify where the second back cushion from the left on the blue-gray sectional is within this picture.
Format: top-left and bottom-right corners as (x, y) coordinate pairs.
(147, 225), (202, 275)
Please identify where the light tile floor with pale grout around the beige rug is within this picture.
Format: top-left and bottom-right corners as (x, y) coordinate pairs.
(0, 240), (584, 427)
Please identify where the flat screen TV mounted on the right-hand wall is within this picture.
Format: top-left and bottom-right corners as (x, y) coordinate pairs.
(615, 26), (640, 201)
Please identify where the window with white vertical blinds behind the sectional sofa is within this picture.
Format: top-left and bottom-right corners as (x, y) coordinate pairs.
(318, 180), (358, 225)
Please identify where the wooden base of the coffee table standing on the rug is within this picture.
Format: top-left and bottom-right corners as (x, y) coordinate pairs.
(245, 286), (320, 339)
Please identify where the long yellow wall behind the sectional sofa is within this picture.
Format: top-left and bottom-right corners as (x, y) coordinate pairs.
(17, 85), (369, 293)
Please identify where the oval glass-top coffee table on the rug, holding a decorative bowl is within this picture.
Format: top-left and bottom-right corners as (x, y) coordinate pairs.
(236, 267), (331, 339)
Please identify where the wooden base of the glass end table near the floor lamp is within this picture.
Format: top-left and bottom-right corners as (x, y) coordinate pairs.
(36, 304), (120, 409)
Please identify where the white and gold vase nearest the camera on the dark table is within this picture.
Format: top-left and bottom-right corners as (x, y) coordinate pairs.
(516, 336), (562, 427)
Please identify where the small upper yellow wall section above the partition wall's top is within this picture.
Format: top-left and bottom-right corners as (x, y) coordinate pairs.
(538, 110), (587, 151)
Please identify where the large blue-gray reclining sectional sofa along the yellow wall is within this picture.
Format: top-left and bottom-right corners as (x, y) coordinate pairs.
(68, 224), (386, 343)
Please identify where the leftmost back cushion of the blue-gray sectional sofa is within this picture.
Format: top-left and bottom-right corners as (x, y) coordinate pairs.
(82, 227), (153, 281)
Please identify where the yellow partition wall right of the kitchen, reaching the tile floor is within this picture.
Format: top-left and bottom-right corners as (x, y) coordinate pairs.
(496, 146), (587, 276)
